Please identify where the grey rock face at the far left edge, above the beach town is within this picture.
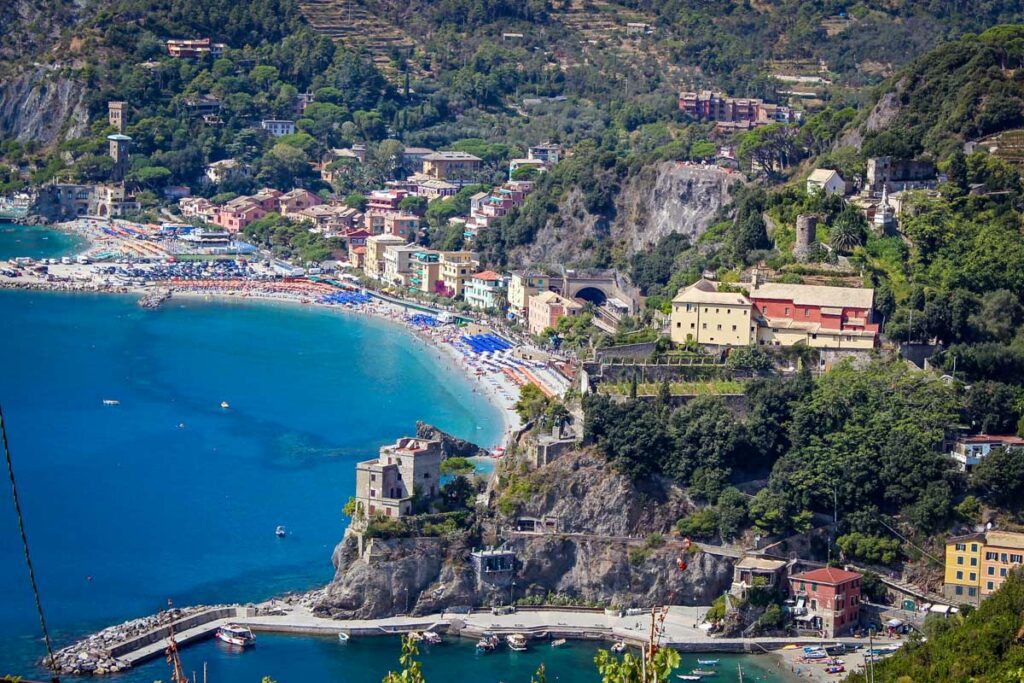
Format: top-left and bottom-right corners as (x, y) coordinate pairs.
(0, 67), (88, 146)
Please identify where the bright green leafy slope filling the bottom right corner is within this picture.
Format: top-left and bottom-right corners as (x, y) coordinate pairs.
(847, 572), (1024, 683)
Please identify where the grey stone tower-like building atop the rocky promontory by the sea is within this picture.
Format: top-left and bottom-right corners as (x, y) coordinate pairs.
(352, 436), (441, 530)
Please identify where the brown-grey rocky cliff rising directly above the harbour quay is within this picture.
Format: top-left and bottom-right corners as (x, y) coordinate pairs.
(317, 453), (732, 618)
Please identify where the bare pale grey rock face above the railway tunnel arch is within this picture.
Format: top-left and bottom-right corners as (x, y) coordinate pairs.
(510, 162), (741, 265)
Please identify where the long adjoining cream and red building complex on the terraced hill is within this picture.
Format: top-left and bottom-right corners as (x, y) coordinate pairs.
(671, 279), (879, 350)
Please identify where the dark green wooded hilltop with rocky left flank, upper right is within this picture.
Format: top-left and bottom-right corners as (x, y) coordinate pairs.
(858, 25), (1024, 158)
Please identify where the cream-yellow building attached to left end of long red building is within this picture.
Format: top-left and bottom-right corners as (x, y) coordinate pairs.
(671, 280), (758, 346)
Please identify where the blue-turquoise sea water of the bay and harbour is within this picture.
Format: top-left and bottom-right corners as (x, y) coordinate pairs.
(0, 227), (790, 683)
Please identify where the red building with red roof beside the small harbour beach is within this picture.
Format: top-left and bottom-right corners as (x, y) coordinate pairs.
(790, 567), (860, 638)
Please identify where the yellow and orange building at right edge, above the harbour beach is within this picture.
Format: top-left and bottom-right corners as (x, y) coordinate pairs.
(942, 529), (1024, 603)
